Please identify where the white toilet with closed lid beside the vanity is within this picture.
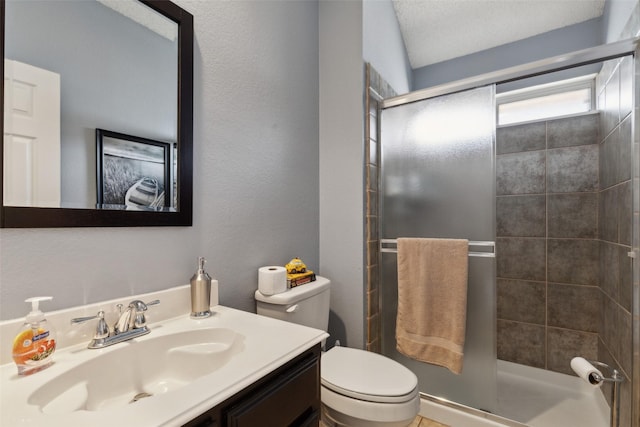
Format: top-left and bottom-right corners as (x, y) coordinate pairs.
(255, 276), (420, 427)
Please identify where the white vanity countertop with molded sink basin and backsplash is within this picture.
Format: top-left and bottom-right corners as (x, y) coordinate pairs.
(0, 285), (327, 427)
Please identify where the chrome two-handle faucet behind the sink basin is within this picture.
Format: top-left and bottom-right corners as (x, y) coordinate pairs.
(71, 300), (160, 349)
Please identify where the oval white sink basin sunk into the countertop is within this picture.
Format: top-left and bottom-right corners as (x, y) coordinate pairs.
(28, 328), (244, 414)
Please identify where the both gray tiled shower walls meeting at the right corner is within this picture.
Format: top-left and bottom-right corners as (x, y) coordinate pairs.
(496, 57), (633, 426)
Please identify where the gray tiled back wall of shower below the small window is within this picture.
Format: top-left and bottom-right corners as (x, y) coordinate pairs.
(496, 113), (602, 373)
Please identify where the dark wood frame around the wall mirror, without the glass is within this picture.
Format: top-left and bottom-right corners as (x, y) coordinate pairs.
(0, 0), (193, 228)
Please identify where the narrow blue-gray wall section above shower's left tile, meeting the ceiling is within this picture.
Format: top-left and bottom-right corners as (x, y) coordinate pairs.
(362, 0), (413, 93)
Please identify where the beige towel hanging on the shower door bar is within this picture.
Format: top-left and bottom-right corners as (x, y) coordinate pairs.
(396, 238), (469, 374)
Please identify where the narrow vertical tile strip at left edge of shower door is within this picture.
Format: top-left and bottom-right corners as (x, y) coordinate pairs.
(364, 63), (396, 353)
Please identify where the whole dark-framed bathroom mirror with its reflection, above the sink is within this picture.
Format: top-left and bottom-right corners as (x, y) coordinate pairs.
(0, 0), (193, 228)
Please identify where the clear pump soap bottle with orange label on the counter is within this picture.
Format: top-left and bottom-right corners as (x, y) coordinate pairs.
(13, 297), (56, 375)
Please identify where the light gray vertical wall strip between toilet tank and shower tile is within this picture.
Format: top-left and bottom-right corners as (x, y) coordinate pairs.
(319, 0), (365, 348)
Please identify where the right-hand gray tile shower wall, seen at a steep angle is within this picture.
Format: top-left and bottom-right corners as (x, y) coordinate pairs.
(596, 57), (634, 426)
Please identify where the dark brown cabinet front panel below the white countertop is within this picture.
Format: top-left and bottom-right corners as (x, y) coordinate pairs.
(226, 357), (320, 427)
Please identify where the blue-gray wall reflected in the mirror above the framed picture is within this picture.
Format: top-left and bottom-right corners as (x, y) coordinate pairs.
(5, 1), (178, 208)
